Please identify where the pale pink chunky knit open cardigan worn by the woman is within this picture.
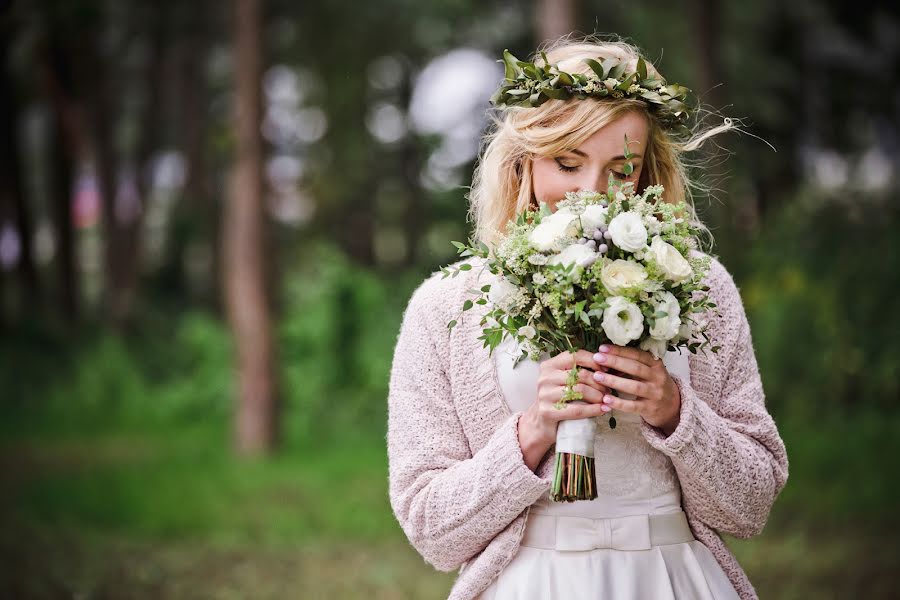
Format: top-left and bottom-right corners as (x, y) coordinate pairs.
(387, 258), (788, 600)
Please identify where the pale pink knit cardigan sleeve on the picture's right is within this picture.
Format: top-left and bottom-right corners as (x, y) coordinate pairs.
(643, 259), (788, 538)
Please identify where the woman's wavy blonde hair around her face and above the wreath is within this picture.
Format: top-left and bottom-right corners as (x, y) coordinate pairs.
(468, 36), (734, 251)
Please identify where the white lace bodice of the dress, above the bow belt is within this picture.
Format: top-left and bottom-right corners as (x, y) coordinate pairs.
(494, 338), (690, 518)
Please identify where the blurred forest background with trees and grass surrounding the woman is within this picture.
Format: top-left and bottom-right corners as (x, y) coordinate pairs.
(0, 0), (900, 599)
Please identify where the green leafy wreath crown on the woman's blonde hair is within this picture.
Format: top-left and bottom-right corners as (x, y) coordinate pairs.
(491, 50), (690, 128)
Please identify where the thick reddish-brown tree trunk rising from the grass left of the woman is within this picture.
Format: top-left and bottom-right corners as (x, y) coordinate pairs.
(222, 0), (276, 455)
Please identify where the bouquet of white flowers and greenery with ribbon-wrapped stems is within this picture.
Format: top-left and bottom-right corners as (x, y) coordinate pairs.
(442, 152), (719, 502)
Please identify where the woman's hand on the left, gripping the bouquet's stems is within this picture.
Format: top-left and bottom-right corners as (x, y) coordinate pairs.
(519, 350), (610, 471)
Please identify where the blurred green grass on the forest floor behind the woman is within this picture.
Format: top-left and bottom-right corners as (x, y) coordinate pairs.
(0, 408), (900, 599)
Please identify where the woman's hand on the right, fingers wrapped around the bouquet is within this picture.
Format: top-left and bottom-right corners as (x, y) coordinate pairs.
(594, 344), (681, 436)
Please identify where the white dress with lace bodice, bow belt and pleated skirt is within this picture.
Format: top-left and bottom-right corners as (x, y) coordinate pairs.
(480, 340), (738, 600)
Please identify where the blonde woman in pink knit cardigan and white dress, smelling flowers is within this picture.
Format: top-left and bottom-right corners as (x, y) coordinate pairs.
(388, 40), (787, 600)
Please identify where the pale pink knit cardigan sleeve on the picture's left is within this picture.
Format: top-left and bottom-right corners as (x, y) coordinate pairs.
(388, 282), (549, 571)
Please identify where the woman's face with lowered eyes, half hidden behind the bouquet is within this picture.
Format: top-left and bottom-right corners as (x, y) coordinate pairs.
(531, 112), (649, 210)
